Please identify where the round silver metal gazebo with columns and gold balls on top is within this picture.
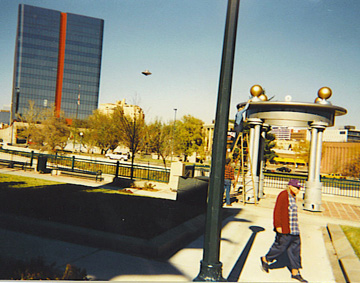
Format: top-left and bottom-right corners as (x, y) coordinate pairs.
(237, 85), (347, 211)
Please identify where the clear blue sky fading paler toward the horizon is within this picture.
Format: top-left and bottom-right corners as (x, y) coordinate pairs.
(0, 0), (360, 128)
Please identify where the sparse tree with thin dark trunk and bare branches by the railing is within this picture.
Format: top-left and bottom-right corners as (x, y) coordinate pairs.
(113, 107), (145, 179)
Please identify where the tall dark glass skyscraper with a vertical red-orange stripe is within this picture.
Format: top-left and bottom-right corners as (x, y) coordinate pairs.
(11, 4), (104, 121)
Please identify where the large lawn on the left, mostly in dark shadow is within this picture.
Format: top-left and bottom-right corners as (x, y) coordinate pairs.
(0, 174), (205, 239)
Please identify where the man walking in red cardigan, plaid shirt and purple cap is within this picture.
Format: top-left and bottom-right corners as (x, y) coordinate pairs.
(260, 179), (308, 282)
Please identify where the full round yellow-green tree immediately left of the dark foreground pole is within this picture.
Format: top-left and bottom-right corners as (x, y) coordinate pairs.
(174, 115), (204, 161)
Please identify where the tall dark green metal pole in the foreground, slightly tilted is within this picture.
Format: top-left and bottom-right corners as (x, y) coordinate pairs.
(194, 0), (240, 281)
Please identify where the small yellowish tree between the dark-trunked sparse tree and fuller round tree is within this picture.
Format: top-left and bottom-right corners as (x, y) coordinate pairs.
(146, 119), (174, 168)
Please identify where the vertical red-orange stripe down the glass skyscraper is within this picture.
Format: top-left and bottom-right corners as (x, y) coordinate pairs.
(55, 13), (67, 117)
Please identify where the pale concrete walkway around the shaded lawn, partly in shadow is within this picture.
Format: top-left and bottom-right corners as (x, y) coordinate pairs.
(0, 168), (360, 282)
